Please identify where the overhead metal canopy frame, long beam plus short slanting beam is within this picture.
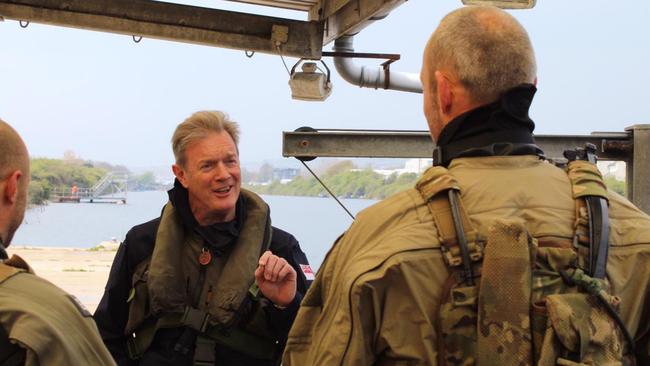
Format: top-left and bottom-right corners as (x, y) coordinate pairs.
(0, 0), (406, 59)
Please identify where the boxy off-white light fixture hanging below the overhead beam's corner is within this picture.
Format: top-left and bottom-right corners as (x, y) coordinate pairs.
(289, 59), (332, 101)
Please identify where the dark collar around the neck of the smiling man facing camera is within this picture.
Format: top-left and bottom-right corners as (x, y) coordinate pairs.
(167, 179), (246, 256)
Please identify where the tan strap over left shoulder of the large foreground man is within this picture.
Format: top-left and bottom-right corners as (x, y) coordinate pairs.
(415, 166), (483, 286)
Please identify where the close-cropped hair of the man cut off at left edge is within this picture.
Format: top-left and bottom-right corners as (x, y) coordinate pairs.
(0, 119), (29, 182)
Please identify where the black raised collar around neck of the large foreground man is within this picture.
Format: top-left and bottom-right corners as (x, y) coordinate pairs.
(433, 84), (544, 167)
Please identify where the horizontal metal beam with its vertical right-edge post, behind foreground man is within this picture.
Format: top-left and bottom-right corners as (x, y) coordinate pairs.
(282, 125), (650, 213)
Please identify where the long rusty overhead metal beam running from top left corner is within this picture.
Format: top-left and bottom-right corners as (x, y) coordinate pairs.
(0, 0), (323, 59)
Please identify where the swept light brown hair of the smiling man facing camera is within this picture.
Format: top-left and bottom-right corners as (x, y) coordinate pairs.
(172, 111), (239, 166)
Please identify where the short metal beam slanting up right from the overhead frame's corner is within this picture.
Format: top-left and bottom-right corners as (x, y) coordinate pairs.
(318, 0), (406, 45)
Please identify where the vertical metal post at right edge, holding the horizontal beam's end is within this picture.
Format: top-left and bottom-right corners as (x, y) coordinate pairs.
(626, 125), (650, 213)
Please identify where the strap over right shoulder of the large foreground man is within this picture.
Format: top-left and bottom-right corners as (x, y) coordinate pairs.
(566, 157), (609, 279)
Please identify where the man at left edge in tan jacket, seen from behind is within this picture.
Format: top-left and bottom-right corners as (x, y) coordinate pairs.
(0, 120), (114, 365)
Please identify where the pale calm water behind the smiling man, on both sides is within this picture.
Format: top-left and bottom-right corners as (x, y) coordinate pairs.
(12, 191), (375, 269)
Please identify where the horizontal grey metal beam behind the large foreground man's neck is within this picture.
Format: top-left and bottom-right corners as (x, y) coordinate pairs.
(282, 130), (632, 160)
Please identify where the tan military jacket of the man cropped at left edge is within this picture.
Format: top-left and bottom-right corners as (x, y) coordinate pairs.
(0, 256), (115, 366)
